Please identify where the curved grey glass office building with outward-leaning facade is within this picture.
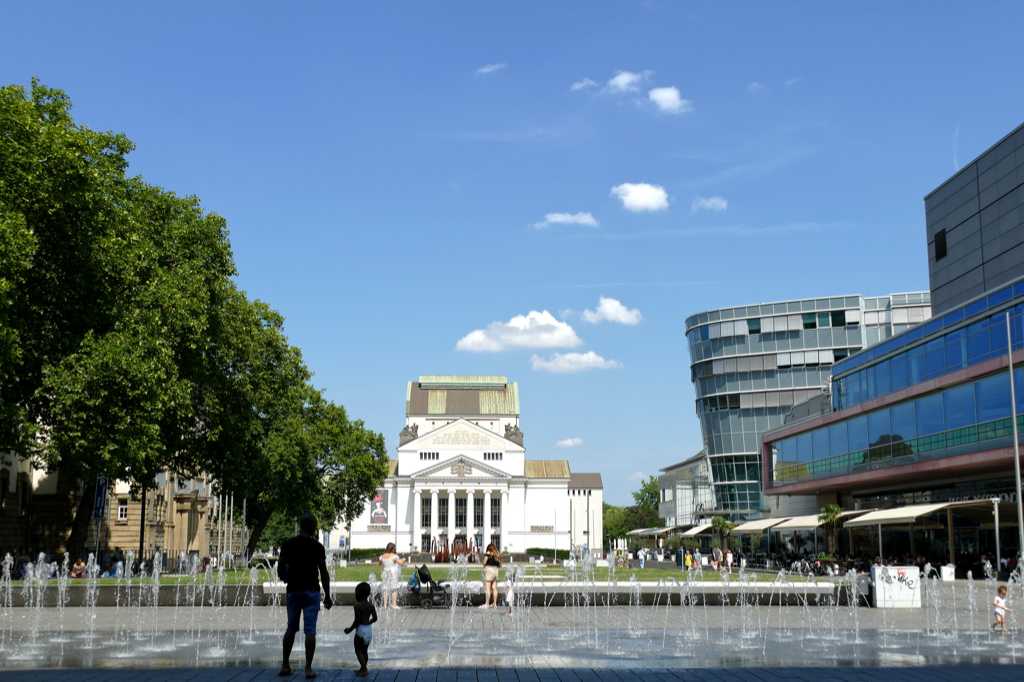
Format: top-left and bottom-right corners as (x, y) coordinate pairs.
(684, 292), (931, 520)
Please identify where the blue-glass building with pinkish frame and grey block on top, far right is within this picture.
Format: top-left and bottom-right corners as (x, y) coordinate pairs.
(762, 120), (1024, 554)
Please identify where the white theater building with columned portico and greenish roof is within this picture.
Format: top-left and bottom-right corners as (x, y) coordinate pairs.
(349, 376), (603, 553)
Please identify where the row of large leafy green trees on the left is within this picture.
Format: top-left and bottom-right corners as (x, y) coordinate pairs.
(0, 80), (387, 553)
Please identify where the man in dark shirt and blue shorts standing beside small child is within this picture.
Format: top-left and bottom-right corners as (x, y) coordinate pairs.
(278, 514), (334, 680)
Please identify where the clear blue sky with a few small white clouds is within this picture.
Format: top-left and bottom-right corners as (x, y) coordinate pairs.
(6, 2), (1024, 504)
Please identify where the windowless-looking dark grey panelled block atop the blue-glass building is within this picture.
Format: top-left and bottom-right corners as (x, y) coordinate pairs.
(925, 120), (1024, 315)
